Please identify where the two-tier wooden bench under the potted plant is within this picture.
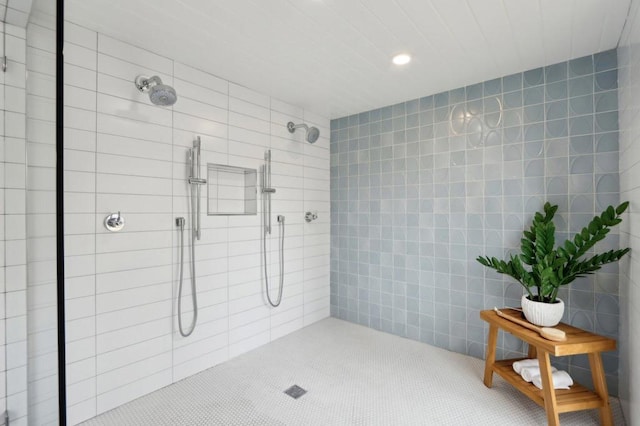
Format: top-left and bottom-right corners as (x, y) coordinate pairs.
(480, 309), (616, 425)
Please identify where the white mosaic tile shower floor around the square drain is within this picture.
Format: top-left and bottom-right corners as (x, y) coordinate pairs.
(83, 318), (624, 426)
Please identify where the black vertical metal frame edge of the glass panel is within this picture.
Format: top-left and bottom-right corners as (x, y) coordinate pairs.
(56, 0), (67, 426)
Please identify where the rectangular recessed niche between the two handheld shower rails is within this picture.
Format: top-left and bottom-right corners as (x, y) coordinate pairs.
(207, 163), (258, 216)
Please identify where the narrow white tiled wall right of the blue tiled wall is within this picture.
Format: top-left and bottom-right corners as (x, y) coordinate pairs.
(613, 1), (640, 425)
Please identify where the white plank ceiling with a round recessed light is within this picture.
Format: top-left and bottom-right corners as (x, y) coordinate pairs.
(65, 0), (631, 118)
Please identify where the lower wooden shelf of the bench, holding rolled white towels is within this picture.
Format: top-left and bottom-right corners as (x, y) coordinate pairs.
(493, 358), (605, 413)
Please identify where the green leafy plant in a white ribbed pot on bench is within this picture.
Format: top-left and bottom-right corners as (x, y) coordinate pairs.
(476, 202), (629, 327)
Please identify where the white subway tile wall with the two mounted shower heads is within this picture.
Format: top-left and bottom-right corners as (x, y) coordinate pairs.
(60, 22), (330, 424)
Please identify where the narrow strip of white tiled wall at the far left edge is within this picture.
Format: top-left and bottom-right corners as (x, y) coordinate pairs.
(0, 19), (28, 425)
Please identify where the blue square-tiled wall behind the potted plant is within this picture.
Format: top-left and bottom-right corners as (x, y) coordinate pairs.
(331, 50), (619, 392)
